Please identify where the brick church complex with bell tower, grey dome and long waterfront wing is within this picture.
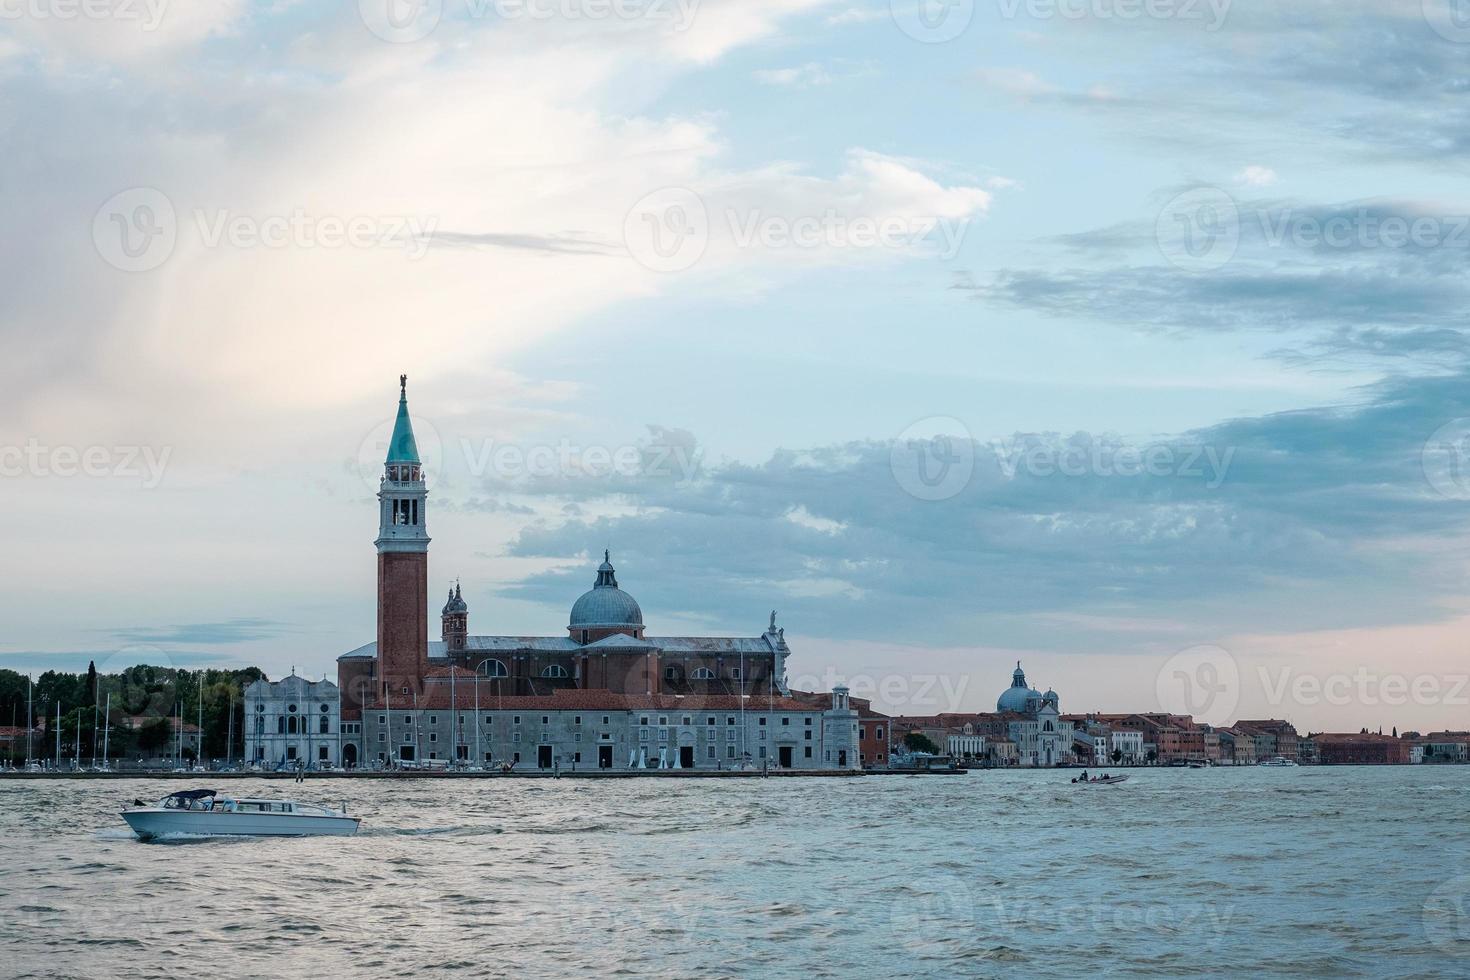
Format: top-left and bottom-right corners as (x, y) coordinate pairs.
(337, 378), (861, 770)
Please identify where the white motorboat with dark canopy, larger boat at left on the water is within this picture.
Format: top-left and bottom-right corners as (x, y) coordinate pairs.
(122, 789), (362, 840)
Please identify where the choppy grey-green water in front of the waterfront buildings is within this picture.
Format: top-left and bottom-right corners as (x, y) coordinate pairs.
(0, 767), (1470, 980)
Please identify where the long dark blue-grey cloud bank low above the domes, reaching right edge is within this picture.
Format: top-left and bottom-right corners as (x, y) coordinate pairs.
(485, 370), (1470, 649)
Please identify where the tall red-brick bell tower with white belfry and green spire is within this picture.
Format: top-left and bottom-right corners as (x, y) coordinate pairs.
(373, 375), (429, 699)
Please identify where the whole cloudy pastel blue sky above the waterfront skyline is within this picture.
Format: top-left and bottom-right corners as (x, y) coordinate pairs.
(0, 0), (1470, 732)
